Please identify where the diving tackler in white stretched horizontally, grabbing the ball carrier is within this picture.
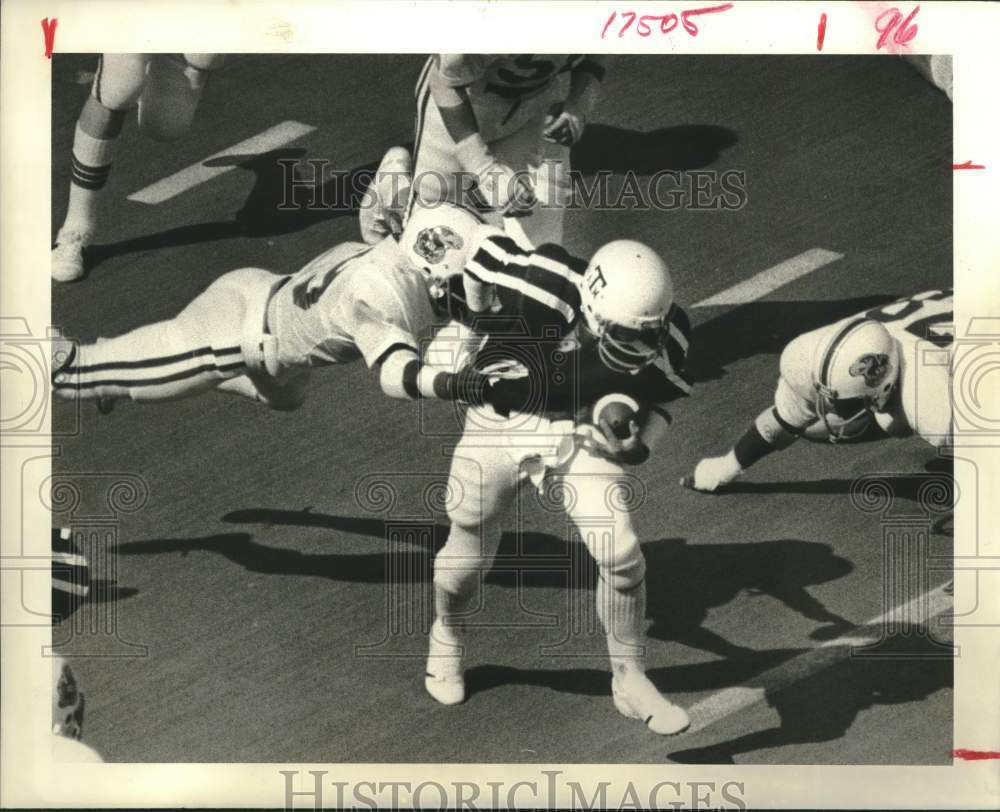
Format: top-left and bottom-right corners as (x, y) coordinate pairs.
(47, 204), (516, 411)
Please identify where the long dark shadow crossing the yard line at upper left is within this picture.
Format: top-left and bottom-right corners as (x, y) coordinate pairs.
(87, 147), (378, 269)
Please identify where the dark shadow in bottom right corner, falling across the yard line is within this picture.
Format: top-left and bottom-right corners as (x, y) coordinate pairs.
(668, 627), (954, 764)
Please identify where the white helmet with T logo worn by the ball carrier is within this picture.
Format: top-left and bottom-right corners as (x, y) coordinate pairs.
(580, 240), (674, 374)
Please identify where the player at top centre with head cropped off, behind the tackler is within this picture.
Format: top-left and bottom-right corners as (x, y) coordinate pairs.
(413, 54), (604, 245)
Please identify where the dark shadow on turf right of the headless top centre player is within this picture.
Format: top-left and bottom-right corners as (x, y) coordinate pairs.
(570, 124), (739, 176)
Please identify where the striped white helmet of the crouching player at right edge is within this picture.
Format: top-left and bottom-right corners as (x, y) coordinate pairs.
(813, 318), (899, 442)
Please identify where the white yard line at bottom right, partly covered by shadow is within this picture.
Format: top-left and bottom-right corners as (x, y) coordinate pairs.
(688, 586), (954, 733)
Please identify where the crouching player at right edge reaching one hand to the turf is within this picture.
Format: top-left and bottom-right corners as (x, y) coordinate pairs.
(682, 290), (953, 491)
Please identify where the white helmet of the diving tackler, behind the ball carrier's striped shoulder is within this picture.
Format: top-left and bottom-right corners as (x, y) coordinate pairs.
(399, 201), (485, 295)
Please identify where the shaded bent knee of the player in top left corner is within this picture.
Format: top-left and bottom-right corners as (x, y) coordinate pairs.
(139, 54), (206, 141)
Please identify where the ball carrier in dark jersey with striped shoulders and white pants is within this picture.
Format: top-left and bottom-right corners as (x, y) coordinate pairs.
(425, 232), (690, 734)
